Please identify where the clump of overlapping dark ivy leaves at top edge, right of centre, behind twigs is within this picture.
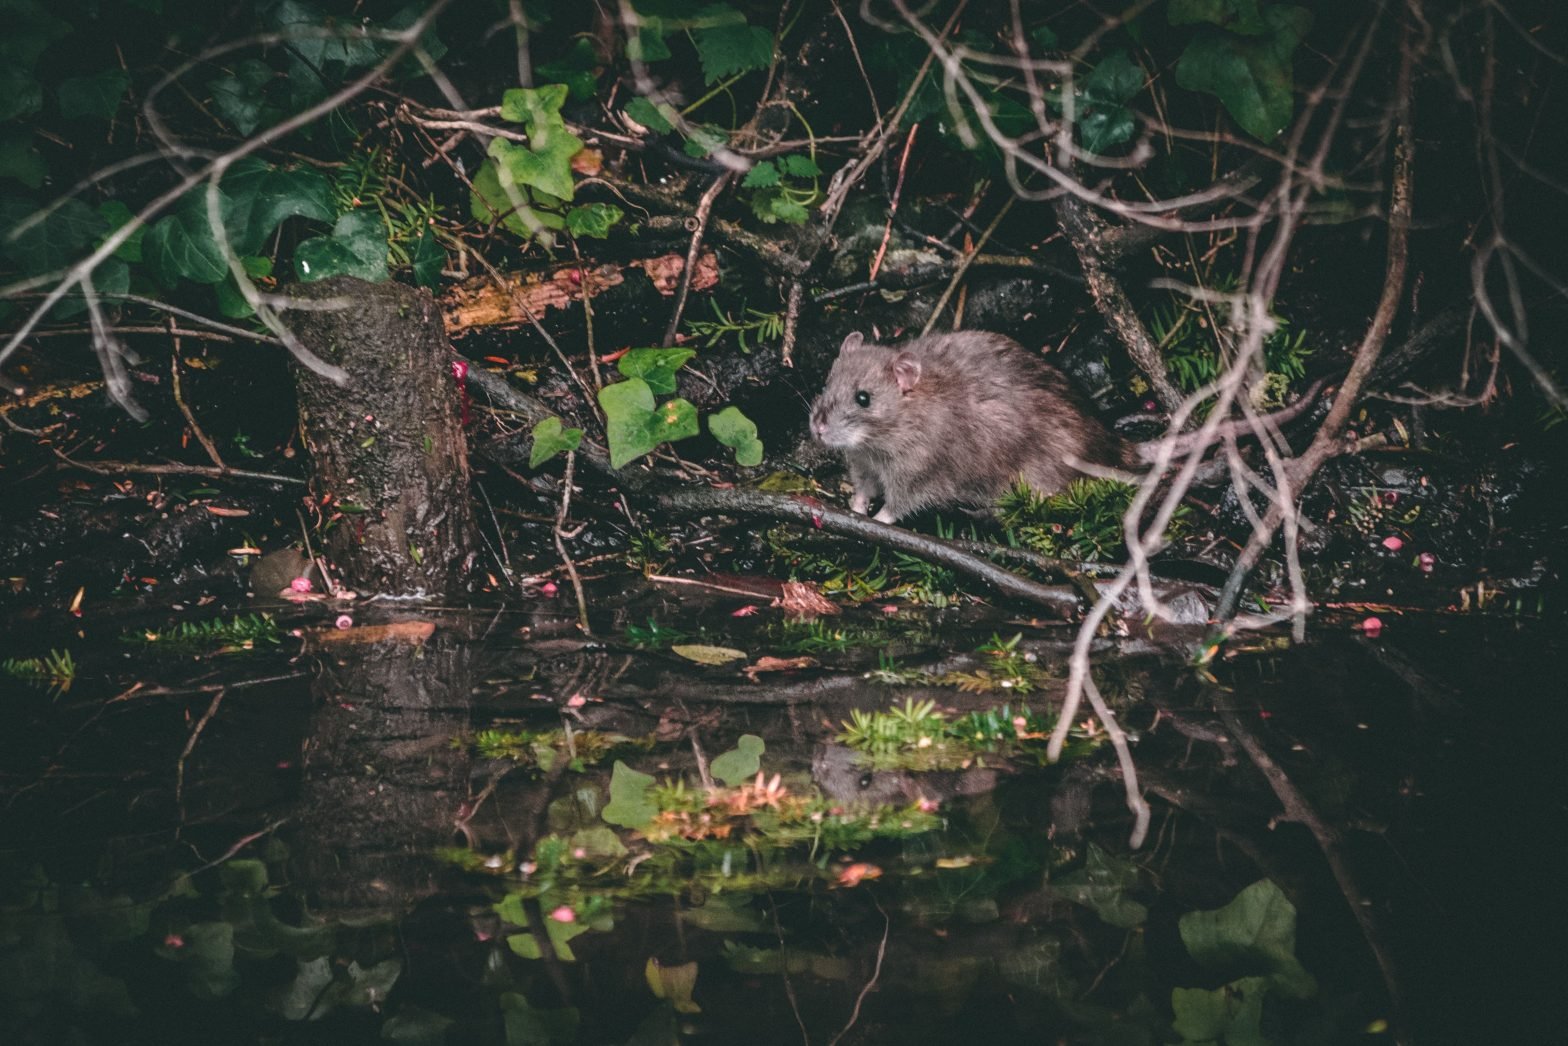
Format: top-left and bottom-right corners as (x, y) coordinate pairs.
(1168, 0), (1312, 141)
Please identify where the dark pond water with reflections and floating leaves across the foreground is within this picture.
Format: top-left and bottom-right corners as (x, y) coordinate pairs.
(0, 601), (1568, 1044)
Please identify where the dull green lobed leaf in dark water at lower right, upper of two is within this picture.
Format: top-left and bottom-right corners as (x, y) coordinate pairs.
(1178, 880), (1317, 999)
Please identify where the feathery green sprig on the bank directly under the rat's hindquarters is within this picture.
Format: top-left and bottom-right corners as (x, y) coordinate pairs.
(997, 477), (1187, 561)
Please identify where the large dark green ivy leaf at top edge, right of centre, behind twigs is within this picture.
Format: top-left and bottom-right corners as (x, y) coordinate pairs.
(1176, 6), (1312, 141)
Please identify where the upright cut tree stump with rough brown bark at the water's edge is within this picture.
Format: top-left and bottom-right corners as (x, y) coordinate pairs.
(289, 276), (477, 599)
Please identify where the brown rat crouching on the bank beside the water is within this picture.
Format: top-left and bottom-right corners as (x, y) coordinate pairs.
(811, 331), (1138, 522)
